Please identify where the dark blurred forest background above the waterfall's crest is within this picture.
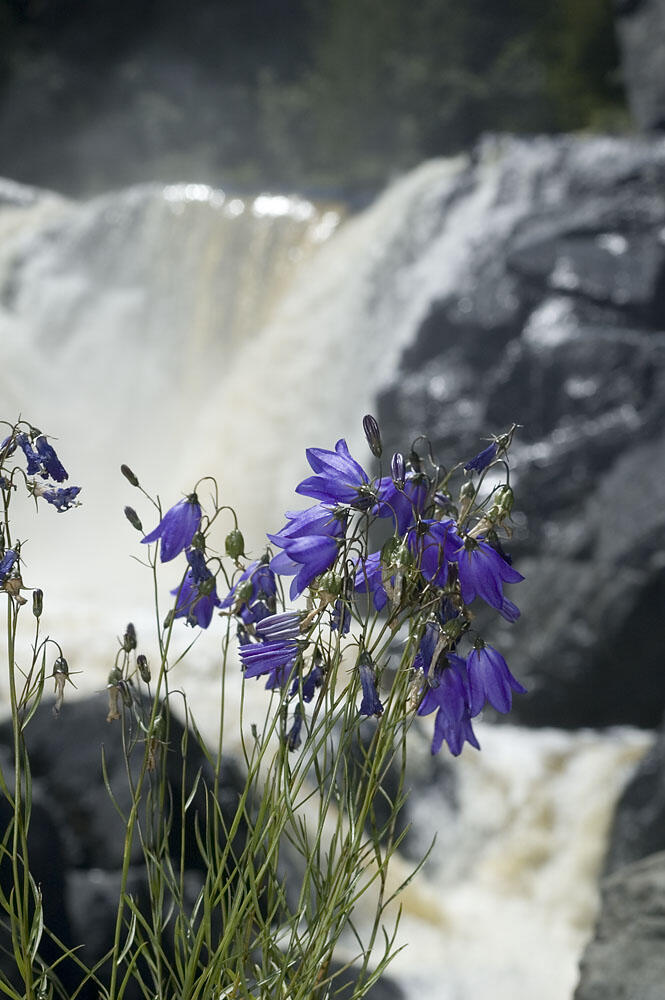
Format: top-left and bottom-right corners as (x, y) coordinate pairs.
(0, 0), (628, 197)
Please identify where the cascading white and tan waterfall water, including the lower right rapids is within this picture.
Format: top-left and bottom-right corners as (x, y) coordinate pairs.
(0, 150), (646, 1000)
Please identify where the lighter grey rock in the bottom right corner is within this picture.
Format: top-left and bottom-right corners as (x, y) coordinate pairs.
(575, 853), (665, 1000)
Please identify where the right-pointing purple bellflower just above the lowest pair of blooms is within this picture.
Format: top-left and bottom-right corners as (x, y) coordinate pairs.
(446, 532), (524, 621)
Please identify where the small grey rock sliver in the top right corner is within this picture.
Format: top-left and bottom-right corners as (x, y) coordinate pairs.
(614, 0), (665, 130)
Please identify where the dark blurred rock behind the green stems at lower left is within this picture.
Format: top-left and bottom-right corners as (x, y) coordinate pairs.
(0, 695), (403, 1000)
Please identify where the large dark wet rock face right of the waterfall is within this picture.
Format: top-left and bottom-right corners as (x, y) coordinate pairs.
(379, 133), (665, 727)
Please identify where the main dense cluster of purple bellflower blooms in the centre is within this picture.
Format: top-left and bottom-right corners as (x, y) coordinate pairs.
(139, 416), (525, 755)
